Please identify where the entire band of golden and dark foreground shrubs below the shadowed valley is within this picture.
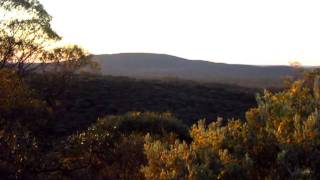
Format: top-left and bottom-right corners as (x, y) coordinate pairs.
(0, 66), (320, 179)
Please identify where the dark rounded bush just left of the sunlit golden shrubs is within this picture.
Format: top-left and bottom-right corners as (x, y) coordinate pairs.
(43, 112), (188, 179)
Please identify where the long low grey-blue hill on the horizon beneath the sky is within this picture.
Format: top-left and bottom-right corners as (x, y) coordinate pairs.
(92, 53), (297, 87)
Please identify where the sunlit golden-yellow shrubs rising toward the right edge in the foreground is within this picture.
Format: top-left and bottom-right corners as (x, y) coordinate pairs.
(142, 73), (320, 179)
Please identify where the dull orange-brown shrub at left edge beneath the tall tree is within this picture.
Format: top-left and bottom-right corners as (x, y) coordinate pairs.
(0, 69), (49, 129)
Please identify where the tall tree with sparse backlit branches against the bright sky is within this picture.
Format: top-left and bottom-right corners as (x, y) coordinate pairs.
(0, 0), (95, 76)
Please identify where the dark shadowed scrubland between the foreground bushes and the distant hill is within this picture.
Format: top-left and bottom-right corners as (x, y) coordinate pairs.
(28, 76), (255, 133)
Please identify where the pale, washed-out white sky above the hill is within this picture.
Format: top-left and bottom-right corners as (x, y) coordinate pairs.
(40, 0), (320, 65)
